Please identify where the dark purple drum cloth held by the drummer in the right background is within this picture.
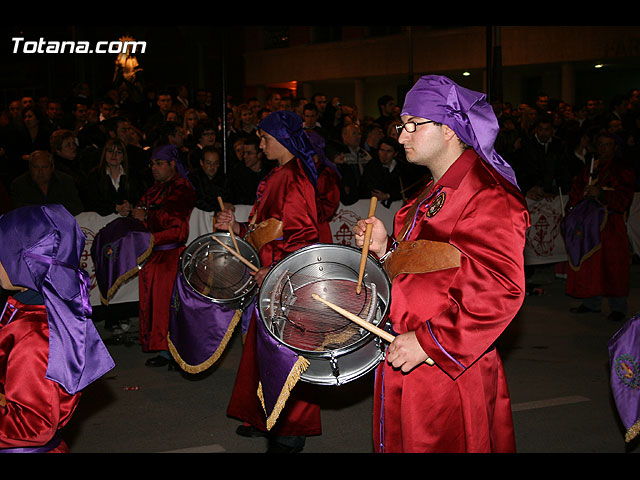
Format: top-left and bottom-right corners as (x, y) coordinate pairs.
(560, 198), (607, 270)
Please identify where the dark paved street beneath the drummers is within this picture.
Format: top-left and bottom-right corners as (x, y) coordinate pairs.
(64, 265), (640, 453)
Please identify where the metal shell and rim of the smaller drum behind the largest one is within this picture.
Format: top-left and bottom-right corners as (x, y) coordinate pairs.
(180, 232), (261, 310)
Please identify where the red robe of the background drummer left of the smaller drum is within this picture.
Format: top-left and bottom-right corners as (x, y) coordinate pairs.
(138, 176), (196, 352)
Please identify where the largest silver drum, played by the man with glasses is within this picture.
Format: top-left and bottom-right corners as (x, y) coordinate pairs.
(258, 244), (391, 385)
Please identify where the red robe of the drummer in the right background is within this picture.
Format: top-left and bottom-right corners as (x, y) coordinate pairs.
(566, 160), (635, 298)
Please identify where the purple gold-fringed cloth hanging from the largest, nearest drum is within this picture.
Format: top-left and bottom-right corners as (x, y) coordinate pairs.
(255, 308), (309, 430)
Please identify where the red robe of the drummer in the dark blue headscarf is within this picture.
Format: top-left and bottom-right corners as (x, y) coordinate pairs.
(227, 159), (322, 436)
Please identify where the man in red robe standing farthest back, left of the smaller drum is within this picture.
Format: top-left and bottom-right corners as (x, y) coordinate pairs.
(131, 145), (196, 368)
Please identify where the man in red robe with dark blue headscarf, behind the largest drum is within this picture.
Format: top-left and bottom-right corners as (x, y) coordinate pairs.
(216, 110), (322, 452)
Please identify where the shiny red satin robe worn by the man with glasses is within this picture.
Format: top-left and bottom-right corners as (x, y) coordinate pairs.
(374, 150), (529, 452)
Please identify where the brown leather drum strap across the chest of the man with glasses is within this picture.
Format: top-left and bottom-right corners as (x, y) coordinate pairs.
(383, 240), (460, 281)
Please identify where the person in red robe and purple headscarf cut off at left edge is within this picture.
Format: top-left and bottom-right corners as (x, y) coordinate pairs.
(0, 205), (114, 453)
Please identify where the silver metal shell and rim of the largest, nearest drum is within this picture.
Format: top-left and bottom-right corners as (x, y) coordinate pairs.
(258, 244), (391, 385)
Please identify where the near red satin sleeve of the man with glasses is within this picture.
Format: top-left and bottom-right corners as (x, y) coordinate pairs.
(410, 186), (529, 378)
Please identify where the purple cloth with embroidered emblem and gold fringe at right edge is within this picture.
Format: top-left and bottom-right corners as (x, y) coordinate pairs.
(608, 314), (640, 442)
